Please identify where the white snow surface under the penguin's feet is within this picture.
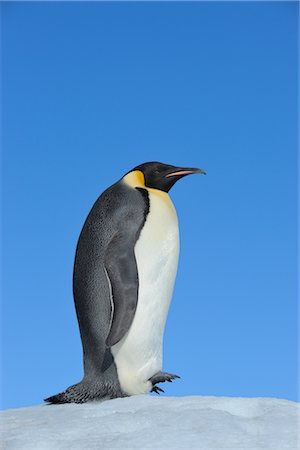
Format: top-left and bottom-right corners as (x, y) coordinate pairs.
(0, 395), (299, 450)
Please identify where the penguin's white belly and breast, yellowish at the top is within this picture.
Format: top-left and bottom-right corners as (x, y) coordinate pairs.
(112, 190), (179, 395)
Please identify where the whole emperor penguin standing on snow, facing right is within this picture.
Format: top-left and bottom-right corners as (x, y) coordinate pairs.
(45, 162), (205, 403)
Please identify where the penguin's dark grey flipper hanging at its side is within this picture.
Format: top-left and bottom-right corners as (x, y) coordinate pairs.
(104, 230), (138, 347)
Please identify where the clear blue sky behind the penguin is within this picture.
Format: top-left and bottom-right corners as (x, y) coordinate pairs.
(1, 2), (298, 408)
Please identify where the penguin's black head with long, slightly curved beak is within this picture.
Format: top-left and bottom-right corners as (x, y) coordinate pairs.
(133, 162), (206, 192)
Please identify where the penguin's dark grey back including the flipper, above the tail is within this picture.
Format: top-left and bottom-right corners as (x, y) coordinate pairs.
(73, 180), (149, 376)
